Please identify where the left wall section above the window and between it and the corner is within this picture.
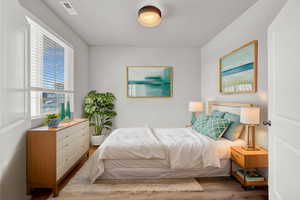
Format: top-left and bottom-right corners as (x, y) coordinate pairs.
(19, 0), (89, 117)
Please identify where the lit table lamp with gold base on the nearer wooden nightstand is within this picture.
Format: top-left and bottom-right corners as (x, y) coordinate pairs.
(240, 107), (260, 151)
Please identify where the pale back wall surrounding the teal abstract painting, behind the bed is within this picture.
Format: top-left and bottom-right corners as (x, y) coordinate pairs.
(89, 47), (201, 127)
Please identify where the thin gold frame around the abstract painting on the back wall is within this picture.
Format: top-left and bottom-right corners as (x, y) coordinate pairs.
(126, 66), (174, 98)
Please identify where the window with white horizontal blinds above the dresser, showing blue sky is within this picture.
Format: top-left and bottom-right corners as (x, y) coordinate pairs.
(29, 20), (74, 118)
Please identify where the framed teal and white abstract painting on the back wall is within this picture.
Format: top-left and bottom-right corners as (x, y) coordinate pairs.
(127, 66), (173, 98)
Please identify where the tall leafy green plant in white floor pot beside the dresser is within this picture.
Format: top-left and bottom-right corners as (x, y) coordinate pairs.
(84, 90), (117, 146)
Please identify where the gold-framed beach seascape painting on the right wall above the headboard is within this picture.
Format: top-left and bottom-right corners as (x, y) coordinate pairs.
(219, 40), (258, 94)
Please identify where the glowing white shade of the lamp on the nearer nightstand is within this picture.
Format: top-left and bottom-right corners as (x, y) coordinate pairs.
(240, 107), (260, 125)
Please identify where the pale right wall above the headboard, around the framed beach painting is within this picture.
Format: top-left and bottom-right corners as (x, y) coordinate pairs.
(201, 0), (286, 147)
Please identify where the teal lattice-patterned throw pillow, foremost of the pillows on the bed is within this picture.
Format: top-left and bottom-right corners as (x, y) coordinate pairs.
(200, 118), (231, 140)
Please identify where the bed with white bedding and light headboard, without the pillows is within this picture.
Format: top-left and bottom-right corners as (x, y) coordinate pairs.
(89, 101), (252, 182)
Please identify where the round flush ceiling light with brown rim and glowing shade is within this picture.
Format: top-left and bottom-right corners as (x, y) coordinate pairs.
(138, 5), (161, 27)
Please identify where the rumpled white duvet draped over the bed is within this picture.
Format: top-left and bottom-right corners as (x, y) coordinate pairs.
(89, 128), (220, 183)
